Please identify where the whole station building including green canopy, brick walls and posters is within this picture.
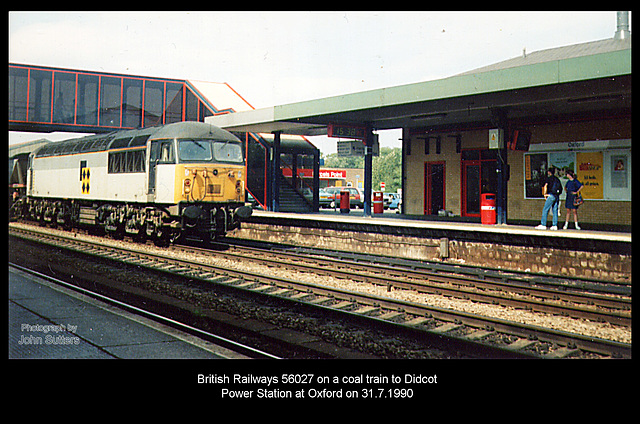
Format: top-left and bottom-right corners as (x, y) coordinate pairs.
(206, 18), (632, 229)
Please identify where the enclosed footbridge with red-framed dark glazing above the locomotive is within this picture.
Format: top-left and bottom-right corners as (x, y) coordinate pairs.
(9, 63), (235, 133)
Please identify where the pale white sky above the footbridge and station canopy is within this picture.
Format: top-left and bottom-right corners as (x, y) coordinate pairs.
(8, 11), (616, 154)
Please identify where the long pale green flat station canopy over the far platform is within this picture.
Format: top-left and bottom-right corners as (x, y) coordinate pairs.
(206, 36), (631, 136)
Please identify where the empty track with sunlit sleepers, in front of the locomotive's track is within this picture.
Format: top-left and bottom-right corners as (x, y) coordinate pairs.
(10, 227), (631, 358)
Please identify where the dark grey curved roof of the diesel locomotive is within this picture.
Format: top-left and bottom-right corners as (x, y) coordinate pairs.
(35, 122), (240, 157)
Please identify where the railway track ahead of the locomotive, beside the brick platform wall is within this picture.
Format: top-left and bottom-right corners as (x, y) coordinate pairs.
(186, 238), (631, 327)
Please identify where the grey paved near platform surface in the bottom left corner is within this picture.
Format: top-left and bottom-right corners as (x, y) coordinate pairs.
(8, 265), (250, 359)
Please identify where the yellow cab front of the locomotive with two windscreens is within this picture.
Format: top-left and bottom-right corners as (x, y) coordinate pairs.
(173, 138), (251, 240)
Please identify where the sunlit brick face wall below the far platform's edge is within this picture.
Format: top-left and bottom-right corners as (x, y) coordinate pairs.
(230, 223), (631, 282)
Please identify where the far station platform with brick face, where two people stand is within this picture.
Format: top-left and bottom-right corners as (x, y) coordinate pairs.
(238, 210), (633, 284)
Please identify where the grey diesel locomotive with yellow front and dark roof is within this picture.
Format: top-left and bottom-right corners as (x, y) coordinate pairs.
(11, 122), (252, 244)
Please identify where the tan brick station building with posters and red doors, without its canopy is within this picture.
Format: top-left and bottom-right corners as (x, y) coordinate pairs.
(404, 39), (632, 226)
